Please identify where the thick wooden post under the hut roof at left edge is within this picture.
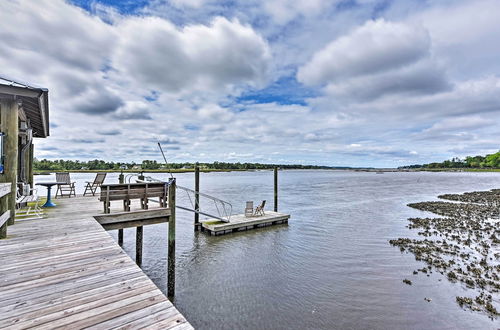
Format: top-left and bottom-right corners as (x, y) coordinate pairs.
(0, 98), (19, 225)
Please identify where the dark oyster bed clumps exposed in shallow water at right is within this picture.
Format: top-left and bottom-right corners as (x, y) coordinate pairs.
(389, 189), (500, 318)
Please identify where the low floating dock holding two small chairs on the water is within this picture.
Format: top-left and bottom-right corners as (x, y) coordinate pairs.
(201, 211), (290, 236)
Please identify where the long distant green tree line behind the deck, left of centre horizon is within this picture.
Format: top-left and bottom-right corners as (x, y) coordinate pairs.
(33, 158), (337, 171)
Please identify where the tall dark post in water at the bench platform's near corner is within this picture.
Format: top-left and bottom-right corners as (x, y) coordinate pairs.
(167, 178), (176, 300)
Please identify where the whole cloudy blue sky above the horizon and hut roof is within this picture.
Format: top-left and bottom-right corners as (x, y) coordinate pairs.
(0, 0), (500, 167)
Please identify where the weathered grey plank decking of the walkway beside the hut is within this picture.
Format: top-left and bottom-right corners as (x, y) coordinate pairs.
(0, 197), (192, 329)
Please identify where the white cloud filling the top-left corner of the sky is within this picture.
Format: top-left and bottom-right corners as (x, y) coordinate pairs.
(0, 1), (115, 72)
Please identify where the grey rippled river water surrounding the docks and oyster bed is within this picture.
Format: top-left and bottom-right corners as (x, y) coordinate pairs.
(36, 171), (500, 329)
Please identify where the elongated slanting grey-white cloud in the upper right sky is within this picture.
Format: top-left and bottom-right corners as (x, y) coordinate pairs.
(297, 19), (430, 85)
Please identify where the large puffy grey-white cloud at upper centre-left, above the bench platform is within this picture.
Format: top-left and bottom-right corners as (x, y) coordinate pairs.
(113, 17), (271, 92)
